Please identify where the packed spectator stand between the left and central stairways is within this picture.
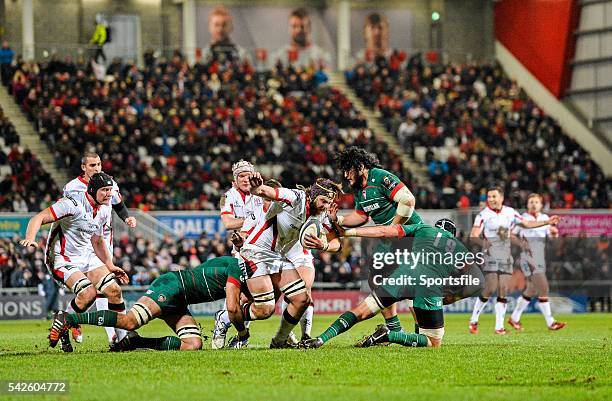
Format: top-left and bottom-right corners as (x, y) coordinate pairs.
(8, 55), (410, 210)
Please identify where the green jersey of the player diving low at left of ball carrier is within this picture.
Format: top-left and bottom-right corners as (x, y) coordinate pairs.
(178, 256), (243, 305)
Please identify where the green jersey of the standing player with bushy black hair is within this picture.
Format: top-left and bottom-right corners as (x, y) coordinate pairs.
(354, 168), (423, 225)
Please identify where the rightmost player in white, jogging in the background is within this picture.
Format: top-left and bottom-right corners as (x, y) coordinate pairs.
(508, 194), (566, 331)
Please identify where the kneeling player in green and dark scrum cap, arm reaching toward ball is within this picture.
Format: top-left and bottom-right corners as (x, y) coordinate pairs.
(300, 219), (484, 348)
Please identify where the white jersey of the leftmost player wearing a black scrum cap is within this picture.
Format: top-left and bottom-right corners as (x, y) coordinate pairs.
(45, 192), (113, 262)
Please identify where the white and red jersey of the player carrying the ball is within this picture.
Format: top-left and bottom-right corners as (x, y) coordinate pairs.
(243, 188), (330, 256)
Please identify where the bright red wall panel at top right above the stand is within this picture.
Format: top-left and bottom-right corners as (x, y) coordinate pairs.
(494, 0), (579, 99)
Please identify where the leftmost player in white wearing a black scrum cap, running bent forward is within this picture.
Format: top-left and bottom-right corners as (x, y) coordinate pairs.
(21, 173), (128, 352)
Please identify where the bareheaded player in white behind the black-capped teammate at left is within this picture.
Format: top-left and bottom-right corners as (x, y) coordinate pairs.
(61, 152), (136, 348)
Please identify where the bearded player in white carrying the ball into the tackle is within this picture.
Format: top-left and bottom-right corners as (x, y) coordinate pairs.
(240, 172), (342, 348)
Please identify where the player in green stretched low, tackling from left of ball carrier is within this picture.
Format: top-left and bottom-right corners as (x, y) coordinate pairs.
(51, 256), (249, 351)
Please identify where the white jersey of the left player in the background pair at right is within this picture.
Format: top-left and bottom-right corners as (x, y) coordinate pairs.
(474, 206), (523, 263)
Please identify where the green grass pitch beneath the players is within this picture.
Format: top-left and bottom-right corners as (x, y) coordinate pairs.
(0, 314), (612, 401)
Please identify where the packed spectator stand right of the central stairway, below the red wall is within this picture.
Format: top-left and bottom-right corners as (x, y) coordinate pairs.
(346, 55), (611, 208)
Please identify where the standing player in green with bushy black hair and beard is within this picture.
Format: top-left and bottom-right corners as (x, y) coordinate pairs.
(330, 146), (423, 338)
